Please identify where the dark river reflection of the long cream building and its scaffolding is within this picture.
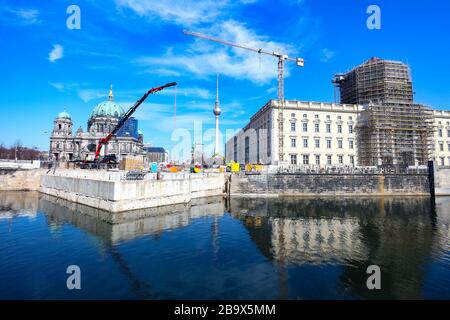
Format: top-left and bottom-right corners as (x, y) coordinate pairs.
(229, 198), (450, 298)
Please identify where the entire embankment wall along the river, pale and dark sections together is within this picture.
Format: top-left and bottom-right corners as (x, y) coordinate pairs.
(0, 168), (450, 212)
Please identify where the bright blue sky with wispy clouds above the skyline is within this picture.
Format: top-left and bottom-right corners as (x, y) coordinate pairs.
(0, 0), (450, 155)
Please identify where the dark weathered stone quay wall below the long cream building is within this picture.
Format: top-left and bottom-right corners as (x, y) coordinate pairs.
(229, 173), (430, 197)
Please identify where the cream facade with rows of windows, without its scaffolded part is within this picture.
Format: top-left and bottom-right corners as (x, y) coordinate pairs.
(226, 100), (450, 166)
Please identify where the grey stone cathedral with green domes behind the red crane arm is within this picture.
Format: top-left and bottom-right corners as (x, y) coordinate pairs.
(50, 89), (144, 161)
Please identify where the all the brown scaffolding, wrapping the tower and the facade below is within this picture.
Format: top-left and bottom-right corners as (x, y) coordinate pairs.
(332, 58), (434, 166)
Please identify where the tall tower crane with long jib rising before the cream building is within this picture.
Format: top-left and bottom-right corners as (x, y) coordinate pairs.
(183, 30), (305, 162)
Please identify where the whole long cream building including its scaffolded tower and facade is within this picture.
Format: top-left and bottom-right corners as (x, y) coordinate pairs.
(226, 58), (450, 166)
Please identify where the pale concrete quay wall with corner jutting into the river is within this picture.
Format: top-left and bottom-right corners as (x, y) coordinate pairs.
(40, 172), (225, 212)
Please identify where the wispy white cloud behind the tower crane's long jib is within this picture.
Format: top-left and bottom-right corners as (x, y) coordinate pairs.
(136, 20), (296, 83)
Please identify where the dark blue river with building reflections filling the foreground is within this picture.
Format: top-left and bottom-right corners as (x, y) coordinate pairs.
(0, 192), (450, 299)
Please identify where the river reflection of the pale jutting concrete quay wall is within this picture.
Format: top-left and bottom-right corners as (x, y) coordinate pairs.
(39, 194), (225, 244)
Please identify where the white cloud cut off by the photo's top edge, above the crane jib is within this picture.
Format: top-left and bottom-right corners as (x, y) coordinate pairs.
(116, 0), (256, 26)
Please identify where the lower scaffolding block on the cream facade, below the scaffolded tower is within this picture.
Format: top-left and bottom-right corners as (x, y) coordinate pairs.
(356, 104), (434, 167)
